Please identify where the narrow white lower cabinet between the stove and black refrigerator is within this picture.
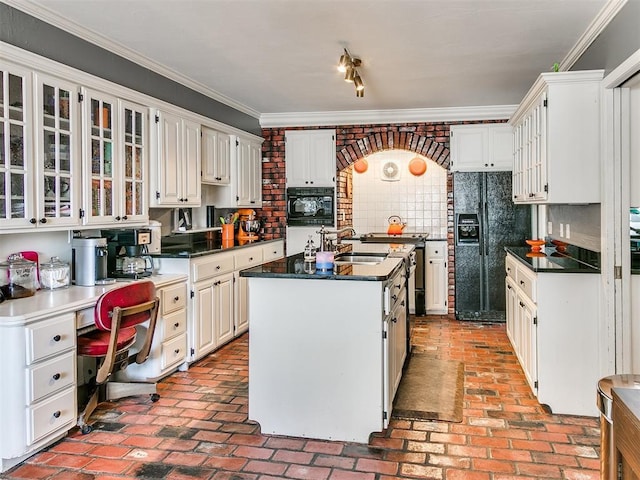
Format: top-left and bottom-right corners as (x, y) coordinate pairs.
(425, 242), (449, 314)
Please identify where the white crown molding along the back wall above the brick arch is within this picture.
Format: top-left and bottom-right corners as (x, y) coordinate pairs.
(260, 105), (517, 128)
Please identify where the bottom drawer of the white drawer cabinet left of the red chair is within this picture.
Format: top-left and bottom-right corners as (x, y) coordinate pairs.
(27, 387), (77, 445)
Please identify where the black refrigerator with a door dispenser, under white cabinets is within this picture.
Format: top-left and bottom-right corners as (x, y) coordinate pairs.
(453, 172), (531, 321)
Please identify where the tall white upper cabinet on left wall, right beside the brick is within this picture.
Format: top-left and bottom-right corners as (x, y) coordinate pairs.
(209, 135), (262, 208)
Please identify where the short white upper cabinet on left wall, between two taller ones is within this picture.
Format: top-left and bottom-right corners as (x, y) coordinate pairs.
(202, 127), (231, 185)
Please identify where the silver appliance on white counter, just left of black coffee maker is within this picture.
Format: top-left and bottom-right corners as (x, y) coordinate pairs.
(71, 237), (115, 287)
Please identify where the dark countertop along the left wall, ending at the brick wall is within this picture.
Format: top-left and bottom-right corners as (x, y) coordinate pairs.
(151, 234), (282, 258)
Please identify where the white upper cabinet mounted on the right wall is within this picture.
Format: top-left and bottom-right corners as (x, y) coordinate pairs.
(509, 70), (603, 204)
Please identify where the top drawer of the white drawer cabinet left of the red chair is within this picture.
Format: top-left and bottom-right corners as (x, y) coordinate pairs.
(25, 313), (76, 365)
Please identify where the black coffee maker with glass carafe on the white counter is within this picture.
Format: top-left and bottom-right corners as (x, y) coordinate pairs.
(101, 228), (153, 279)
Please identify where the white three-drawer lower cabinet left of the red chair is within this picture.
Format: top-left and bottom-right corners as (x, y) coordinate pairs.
(0, 313), (77, 471)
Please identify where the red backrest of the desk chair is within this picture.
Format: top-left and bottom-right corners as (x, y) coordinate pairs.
(94, 281), (156, 331)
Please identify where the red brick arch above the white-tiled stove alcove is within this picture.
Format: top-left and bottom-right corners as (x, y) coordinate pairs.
(336, 130), (449, 170)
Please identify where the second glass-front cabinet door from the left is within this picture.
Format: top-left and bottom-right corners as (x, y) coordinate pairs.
(29, 74), (81, 227)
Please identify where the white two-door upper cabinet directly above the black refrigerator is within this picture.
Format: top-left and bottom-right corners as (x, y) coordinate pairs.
(449, 124), (513, 172)
